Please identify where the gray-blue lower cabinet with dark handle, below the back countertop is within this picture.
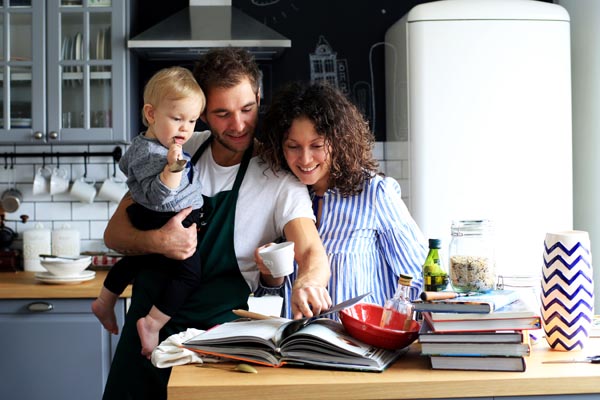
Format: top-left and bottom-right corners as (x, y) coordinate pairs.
(0, 299), (125, 400)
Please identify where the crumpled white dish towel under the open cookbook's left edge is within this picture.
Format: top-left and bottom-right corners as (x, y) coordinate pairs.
(151, 328), (219, 368)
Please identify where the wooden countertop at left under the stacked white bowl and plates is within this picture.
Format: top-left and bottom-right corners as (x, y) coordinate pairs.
(0, 271), (131, 300)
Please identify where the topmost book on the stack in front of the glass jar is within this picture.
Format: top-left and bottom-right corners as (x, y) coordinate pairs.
(414, 290), (520, 314)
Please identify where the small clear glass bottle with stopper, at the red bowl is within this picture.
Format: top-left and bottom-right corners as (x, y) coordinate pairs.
(379, 274), (414, 330)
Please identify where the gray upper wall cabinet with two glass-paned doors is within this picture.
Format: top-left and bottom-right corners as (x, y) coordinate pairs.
(0, 0), (129, 144)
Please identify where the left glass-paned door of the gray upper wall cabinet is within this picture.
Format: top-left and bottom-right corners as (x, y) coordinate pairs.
(0, 0), (45, 143)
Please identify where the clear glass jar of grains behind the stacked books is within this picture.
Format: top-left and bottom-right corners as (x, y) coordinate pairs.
(448, 220), (496, 293)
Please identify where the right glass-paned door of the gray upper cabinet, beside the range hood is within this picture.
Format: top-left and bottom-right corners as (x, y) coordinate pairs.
(48, 0), (125, 143)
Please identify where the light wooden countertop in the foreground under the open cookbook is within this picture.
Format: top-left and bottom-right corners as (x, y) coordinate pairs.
(168, 338), (600, 400)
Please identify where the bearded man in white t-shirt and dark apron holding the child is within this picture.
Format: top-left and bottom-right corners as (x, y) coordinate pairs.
(104, 48), (331, 400)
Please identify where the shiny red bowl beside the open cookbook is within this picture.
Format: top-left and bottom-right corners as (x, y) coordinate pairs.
(340, 303), (421, 350)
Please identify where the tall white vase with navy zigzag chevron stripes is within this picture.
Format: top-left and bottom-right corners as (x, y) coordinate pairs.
(541, 231), (594, 351)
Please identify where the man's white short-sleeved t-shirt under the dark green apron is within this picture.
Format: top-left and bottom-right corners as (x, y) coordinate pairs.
(184, 131), (315, 291)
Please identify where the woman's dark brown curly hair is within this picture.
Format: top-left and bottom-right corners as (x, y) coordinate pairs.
(259, 82), (378, 196)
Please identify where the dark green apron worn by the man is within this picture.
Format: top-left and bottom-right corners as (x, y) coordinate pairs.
(103, 140), (252, 400)
